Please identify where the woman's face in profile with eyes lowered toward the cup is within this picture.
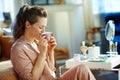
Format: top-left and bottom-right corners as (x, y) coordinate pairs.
(27, 17), (47, 39)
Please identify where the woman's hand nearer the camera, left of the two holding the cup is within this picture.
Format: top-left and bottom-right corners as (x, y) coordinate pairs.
(37, 36), (48, 54)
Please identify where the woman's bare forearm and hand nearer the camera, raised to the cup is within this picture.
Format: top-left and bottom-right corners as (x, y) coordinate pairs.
(32, 37), (48, 80)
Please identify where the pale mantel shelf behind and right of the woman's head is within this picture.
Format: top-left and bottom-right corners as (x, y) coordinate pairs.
(38, 4), (81, 12)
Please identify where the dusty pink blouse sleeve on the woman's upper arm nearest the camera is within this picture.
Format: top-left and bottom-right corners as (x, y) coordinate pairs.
(11, 46), (33, 80)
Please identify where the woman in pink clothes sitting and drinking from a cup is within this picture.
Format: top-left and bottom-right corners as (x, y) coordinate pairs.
(11, 5), (95, 80)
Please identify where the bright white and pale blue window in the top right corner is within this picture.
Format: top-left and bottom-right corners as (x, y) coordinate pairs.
(92, 0), (120, 14)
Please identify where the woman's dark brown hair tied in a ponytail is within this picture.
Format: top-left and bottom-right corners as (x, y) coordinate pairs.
(12, 5), (47, 40)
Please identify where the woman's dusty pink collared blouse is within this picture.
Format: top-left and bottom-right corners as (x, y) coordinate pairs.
(11, 36), (55, 80)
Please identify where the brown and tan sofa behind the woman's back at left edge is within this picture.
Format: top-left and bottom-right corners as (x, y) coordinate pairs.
(0, 35), (18, 80)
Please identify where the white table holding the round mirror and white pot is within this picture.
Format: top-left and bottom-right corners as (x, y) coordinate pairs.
(65, 55), (120, 80)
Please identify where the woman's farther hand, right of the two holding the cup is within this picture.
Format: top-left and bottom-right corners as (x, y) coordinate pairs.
(48, 36), (57, 53)
